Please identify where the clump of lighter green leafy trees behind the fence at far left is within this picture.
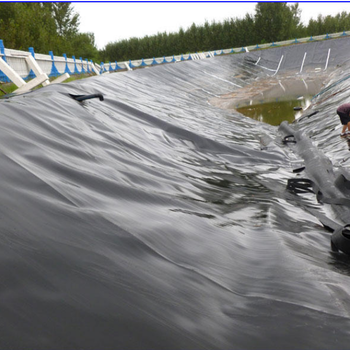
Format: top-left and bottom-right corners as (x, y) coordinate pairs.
(0, 2), (100, 60)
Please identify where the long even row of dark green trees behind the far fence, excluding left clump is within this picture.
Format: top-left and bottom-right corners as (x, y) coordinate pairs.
(100, 2), (350, 62)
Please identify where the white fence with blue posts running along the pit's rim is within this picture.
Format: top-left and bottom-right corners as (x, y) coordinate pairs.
(0, 31), (350, 93)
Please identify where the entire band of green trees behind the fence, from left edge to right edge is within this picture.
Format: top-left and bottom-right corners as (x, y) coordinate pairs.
(0, 2), (350, 62)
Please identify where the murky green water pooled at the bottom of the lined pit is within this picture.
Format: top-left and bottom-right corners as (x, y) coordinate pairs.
(237, 96), (312, 125)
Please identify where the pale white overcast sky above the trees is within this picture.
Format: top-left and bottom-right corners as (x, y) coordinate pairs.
(73, 1), (350, 49)
